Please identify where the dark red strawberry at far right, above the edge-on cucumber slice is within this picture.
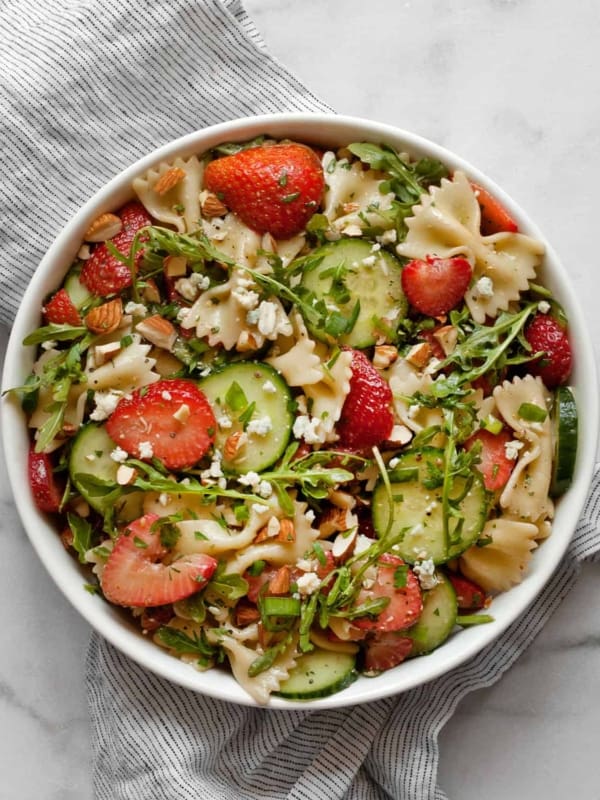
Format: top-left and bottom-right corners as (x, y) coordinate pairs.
(525, 314), (573, 389)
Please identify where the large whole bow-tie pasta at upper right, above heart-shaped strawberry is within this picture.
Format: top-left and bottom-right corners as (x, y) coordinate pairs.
(397, 171), (544, 323)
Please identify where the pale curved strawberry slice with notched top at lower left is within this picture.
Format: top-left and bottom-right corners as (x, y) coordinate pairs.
(101, 514), (217, 608)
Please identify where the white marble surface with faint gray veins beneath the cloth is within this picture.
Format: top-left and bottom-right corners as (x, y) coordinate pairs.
(0, 0), (600, 800)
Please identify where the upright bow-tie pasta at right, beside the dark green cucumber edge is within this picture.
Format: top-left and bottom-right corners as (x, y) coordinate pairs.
(493, 375), (554, 522)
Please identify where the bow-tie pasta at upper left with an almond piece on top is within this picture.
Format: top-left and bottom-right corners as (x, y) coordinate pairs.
(133, 156), (204, 233)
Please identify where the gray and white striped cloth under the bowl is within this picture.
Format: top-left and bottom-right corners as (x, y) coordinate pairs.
(0, 0), (600, 800)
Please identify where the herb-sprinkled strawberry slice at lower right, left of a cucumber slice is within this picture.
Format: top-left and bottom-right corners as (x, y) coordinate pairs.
(353, 553), (423, 631)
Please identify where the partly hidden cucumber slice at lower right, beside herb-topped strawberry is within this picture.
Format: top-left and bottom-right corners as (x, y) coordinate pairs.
(404, 574), (458, 658)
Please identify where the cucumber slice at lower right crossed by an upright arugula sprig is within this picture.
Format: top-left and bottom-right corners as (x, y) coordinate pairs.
(373, 447), (487, 564)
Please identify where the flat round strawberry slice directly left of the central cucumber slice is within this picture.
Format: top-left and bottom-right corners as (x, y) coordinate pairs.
(106, 378), (217, 469)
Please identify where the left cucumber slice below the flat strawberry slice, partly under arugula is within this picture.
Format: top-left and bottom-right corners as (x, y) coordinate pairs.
(69, 423), (144, 522)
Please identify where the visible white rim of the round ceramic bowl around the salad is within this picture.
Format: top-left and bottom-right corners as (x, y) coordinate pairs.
(2, 114), (598, 709)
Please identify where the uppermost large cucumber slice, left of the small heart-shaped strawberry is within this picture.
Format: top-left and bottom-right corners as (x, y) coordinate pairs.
(301, 239), (407, 348)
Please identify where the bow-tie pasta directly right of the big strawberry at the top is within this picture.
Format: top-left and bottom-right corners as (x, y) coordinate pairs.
(323, 152), (394, 235)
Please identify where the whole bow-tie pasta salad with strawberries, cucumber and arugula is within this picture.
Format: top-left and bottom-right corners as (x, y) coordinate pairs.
(14, 137), (577, 704)
